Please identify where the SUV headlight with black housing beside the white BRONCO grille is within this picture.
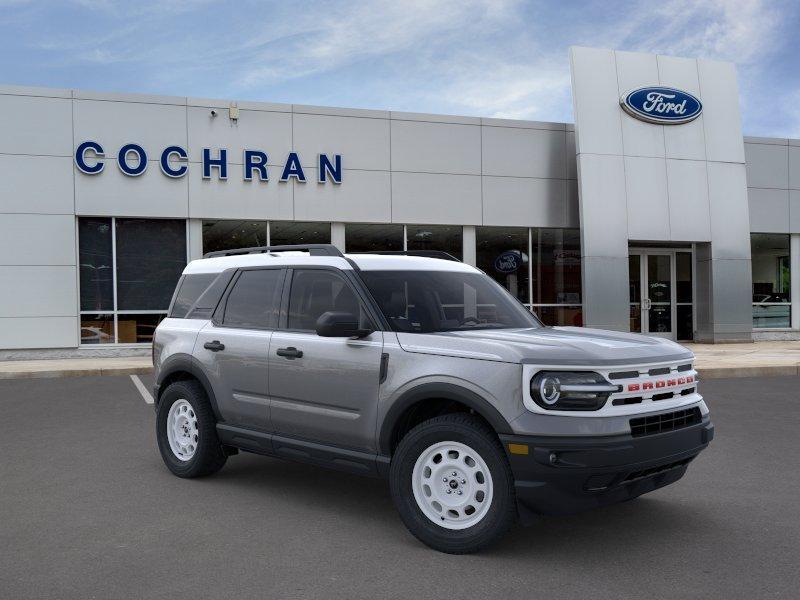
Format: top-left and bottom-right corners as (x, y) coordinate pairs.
(531, 371), (619, 410)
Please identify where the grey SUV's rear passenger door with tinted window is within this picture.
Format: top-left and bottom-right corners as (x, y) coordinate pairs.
(194, 268), (286, 431)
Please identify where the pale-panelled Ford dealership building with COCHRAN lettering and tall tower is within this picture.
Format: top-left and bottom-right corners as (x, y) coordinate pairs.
(0, 48), (800, 360)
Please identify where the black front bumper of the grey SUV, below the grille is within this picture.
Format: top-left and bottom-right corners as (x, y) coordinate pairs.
(500, 415), (714, 517)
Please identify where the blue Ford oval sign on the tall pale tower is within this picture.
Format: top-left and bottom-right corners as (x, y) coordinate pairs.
(619, 87), (703, 125)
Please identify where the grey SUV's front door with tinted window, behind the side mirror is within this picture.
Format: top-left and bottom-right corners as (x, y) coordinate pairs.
(269, 268), (383, 450)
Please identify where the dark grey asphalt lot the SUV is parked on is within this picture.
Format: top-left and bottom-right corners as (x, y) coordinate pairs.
(0, 377), (800, 600)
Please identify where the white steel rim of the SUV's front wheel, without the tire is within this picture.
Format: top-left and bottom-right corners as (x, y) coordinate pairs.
(411, 442), (493, 529)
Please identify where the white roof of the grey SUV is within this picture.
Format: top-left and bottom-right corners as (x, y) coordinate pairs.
(183, 252), (479, 275)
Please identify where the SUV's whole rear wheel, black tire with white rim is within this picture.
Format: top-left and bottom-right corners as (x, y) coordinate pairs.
(156, 381), (227, 477)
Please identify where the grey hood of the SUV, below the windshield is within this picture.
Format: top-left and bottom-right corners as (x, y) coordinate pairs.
(397, 327), (694, 367)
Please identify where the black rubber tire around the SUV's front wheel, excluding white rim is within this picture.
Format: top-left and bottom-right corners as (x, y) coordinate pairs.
(389, 413), (518, 554)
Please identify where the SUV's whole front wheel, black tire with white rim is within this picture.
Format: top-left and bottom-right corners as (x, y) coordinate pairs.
(390, 414), (517, 554)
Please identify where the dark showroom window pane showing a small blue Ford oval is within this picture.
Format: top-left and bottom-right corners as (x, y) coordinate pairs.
(475, 227), (530, 304)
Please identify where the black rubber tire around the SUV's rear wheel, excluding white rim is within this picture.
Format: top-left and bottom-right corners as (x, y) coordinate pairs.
(156, 380), (228, 478)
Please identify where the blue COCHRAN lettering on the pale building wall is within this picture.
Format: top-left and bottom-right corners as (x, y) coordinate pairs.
(75, 141), (342, 183)
